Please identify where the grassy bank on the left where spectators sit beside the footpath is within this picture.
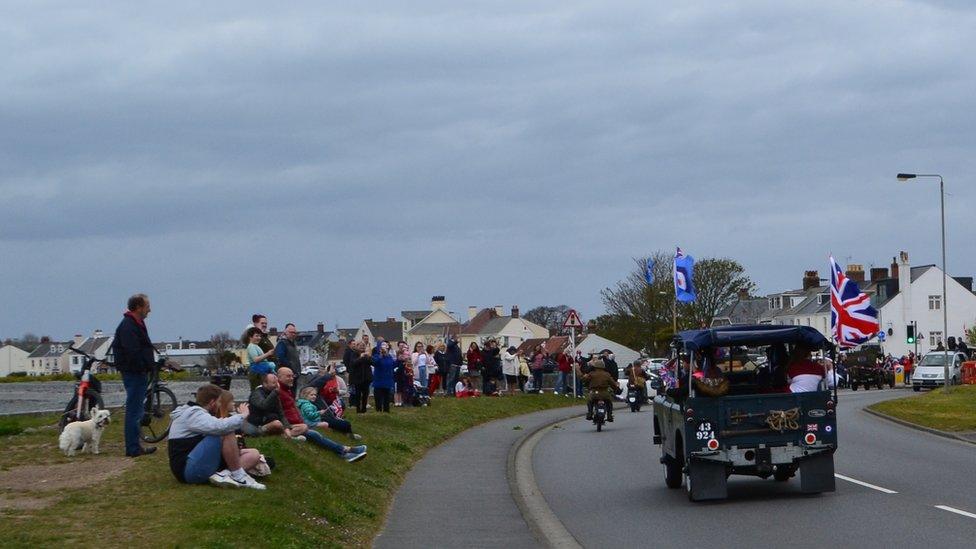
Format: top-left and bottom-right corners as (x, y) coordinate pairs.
(0, 395), (573, 547)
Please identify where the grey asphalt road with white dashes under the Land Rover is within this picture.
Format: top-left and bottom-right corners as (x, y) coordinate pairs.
(533, 389), (976, 549)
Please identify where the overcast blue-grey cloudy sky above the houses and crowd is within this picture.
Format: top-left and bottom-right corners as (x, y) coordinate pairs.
(0, 0), (976, 340)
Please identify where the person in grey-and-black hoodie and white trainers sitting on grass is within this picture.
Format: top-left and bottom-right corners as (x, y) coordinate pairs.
(168, 384), (265, 490)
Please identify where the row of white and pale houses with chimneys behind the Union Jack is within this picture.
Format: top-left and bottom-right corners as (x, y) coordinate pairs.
(712, 252), (976, 356)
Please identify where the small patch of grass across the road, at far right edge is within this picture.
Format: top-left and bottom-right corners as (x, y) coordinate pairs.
(869, 385), (976, 431)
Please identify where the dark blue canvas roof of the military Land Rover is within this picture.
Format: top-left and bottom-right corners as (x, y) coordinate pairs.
(678, 324), (831, 351)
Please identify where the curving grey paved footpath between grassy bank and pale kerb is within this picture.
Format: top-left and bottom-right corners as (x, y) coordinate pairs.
(374, 400), (586, 549)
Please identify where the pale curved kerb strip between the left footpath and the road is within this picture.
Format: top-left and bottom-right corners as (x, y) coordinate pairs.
(508, 406), (584, 548)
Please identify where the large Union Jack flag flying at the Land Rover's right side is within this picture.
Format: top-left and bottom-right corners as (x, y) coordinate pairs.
(830, 256), (881, 347)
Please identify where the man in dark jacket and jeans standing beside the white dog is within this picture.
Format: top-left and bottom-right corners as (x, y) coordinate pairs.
(112, 294), (156, 457)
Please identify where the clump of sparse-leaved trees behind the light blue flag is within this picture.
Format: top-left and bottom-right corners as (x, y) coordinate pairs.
(597, 251), (755, 352)
